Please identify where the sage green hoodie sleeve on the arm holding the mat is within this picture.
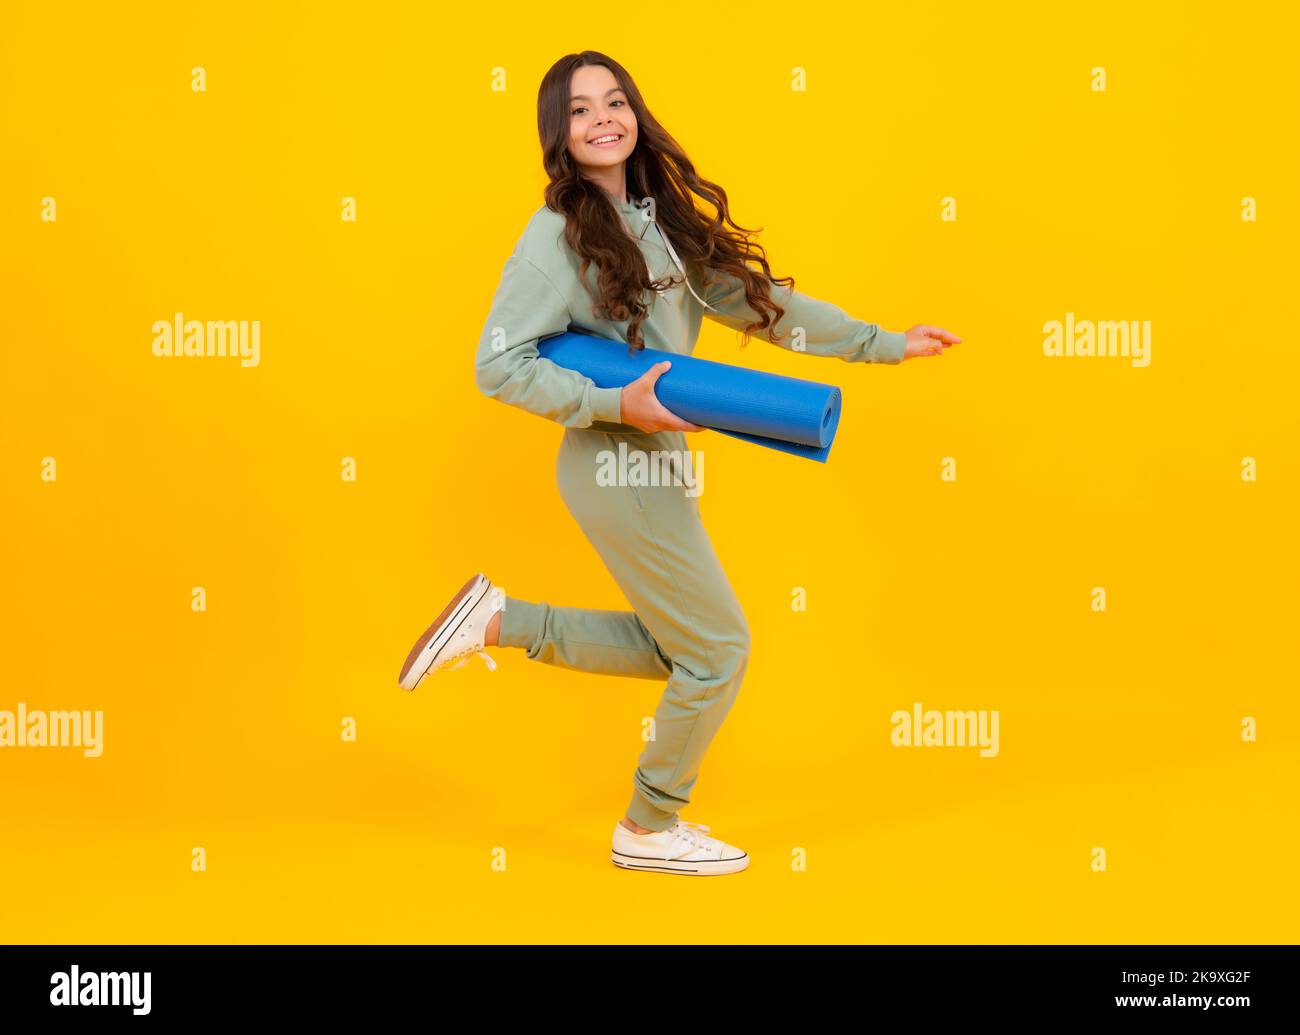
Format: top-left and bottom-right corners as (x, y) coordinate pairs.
(475, 248), (623, 428)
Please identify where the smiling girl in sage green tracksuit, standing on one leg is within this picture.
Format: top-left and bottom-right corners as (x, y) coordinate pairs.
(398, 51), (961, 875)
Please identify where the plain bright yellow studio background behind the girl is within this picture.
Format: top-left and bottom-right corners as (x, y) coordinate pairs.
(0, 3), (1300, 941)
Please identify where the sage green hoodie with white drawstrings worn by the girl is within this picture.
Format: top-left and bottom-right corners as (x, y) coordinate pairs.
(475, 198), (906, 432)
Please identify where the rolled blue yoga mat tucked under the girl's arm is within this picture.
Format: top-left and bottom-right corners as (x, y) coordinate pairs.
(537, 332), (841, 463)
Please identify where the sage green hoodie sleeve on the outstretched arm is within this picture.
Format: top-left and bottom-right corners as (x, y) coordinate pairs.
(705, 269), (907, 364)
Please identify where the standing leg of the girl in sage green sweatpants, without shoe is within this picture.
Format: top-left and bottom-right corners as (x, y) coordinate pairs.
(556, 428), (750, 831)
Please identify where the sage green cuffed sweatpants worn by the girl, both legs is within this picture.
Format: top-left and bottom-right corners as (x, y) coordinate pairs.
(498, 425), (750, 830)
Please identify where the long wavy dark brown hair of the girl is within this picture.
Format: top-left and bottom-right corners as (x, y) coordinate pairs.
(537, 51), (794, 350)
